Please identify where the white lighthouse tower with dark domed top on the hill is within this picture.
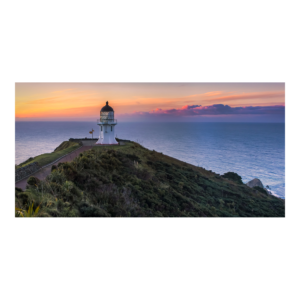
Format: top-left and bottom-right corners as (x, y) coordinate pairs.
(96, 101), (118, 145)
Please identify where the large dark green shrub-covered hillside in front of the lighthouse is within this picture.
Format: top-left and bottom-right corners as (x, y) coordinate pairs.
(15, 142), (285, 217)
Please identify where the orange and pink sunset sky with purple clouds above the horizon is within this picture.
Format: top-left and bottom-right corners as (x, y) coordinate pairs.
(14, 82), (286, 122)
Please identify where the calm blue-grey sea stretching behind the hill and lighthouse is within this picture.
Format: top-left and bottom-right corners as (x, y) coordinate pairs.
(14, 122), (285, 198)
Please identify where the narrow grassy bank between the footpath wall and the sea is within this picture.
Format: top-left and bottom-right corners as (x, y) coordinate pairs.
(17, 142), (80, 168)
